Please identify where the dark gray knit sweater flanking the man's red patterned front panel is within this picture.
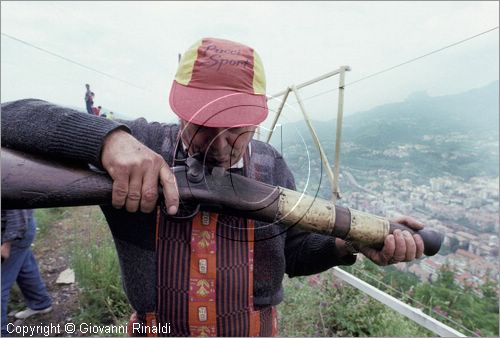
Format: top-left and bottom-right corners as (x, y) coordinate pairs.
(2, 99), (355, 312)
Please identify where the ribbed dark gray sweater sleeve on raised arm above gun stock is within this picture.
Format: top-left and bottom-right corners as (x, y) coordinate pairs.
(2, 99), (130, 168)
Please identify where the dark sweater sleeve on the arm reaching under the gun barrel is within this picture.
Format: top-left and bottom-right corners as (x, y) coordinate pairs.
(275, 149), (356, 277)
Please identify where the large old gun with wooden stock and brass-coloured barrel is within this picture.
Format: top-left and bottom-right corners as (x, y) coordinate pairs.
(2, 148), (443, 256)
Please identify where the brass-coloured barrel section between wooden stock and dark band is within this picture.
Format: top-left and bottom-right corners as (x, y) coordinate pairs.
(276, 187), (335, 235)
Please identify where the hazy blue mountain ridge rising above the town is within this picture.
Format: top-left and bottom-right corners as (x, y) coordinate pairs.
(283, 81), (499, 147)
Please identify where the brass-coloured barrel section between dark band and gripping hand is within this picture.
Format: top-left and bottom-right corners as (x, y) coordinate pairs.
(347, 208), (390, 244)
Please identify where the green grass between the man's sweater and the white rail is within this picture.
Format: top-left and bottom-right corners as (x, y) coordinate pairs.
(278, 272), (434, 337)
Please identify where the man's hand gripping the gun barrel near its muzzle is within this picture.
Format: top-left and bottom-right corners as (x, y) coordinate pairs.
(360, 216), (424, 265)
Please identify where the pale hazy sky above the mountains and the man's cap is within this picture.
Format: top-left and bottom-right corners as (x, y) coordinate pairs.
(1, 1), (499, 121)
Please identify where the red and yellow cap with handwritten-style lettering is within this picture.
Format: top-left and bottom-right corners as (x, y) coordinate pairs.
(170, 38), (268, 127)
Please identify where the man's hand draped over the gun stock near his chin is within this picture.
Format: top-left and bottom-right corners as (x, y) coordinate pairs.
(101, 130), (179, 215)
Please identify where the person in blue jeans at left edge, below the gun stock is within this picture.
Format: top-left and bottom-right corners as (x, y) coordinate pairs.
(2, 210), (52, 336)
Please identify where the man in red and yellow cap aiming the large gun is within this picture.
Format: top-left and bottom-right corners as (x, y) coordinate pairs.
(2, 38), (423, 336)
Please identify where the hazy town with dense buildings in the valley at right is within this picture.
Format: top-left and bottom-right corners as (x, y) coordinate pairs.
(341, 169), (499, 289)
